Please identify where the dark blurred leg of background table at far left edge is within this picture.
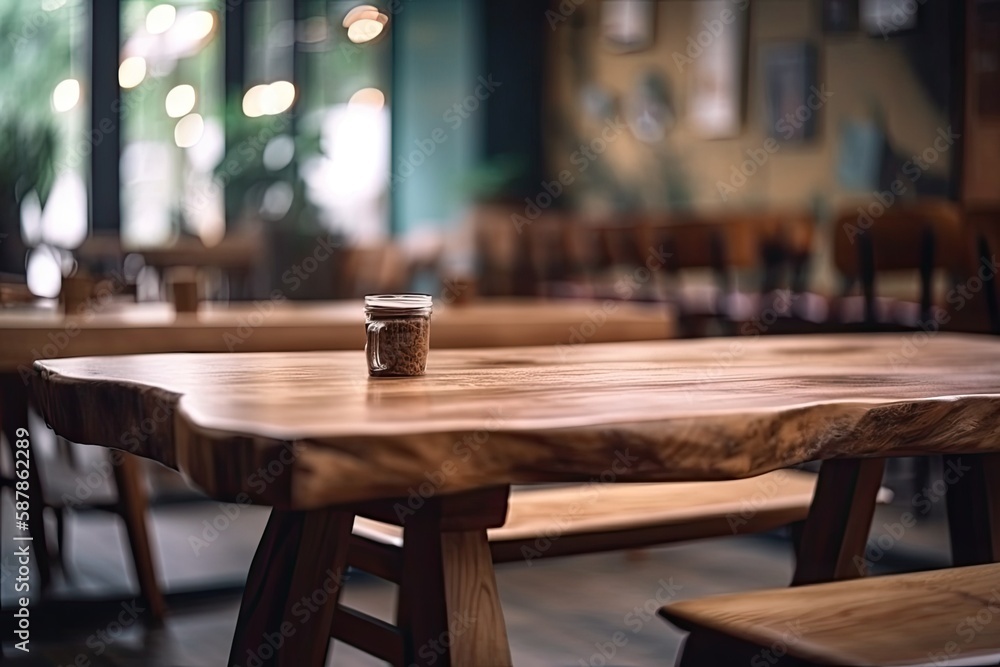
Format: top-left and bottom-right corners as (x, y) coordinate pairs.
(0, 373), (52, 590)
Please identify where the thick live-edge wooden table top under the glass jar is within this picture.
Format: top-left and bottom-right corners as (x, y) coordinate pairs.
(27, 333), (1000, 509)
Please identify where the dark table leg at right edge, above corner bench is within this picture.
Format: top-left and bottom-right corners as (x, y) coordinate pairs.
(944, 454), (1000, 567)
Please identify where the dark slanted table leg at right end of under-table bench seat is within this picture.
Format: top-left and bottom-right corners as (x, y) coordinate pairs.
(792, 459), (885, 586)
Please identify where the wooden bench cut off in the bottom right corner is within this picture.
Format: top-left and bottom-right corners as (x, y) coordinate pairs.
(660, 564), (1000, 667)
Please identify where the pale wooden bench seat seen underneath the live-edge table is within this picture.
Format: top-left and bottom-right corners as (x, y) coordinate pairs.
(354, 470), (891, 562)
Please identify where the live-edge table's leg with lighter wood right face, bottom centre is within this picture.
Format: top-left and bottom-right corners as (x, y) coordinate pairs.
(397, 489), (511, 667)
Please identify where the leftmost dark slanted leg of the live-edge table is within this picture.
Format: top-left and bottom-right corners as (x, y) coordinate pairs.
(229, 509), (354, 667)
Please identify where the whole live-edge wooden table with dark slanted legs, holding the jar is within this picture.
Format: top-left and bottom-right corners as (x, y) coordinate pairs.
(27, 334), (1000, 665)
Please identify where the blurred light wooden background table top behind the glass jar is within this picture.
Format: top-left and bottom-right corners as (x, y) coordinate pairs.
(0, 299), (675, 371)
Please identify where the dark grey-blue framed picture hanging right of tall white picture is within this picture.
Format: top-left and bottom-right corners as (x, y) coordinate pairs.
(761, 41), (826, 143)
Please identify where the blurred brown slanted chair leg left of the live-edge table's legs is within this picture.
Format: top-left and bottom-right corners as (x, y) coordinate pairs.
(113, 452), (166, 623)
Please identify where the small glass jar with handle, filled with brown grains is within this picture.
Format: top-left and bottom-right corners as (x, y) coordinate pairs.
(365, 294), (432, 377)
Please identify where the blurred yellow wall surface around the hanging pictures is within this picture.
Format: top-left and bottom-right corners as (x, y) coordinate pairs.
(546, 0), (950, 212)
